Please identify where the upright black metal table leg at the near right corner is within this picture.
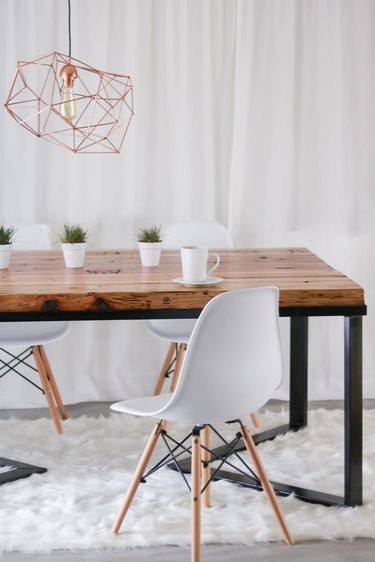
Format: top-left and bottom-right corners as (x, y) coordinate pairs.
(344, 316), (362, 505)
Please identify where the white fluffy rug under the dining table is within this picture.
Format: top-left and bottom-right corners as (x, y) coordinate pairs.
(0, 410), (375, 553)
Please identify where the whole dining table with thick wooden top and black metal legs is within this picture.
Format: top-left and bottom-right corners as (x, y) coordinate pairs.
(0, 247), (367, 506)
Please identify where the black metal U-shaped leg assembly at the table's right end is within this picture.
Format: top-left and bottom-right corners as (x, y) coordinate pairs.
(170, 310), (365, 507)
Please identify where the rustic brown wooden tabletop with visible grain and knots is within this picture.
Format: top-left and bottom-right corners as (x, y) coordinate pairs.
(0, 248), (365, 313)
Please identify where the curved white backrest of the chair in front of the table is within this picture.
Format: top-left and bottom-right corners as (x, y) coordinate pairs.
(160, 287), (284, 424)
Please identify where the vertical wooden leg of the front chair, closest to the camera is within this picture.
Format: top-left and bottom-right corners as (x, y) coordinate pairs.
(191, 426), (201, 562)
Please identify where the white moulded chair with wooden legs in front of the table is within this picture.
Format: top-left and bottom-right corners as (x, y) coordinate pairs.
(111, 287), (293, 562)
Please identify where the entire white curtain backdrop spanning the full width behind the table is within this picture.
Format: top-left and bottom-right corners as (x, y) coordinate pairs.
(0, 0), (375, 402)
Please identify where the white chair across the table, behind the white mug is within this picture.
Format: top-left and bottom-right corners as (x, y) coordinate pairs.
(147, 221), (260, 428)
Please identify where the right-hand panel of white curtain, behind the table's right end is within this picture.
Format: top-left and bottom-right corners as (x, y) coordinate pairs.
(228, 0), (375, 398)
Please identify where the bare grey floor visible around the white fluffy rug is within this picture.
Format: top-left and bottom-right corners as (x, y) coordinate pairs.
(0, 400), (375, 562)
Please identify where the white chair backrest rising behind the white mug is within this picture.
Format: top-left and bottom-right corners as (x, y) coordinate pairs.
(162, 221), (233, 248)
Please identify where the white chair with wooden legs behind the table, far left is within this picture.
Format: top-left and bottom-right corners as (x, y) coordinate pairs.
(0, 224), (70, 433)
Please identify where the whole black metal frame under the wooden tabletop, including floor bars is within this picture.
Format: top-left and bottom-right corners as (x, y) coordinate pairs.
(0, 299), (366, 506)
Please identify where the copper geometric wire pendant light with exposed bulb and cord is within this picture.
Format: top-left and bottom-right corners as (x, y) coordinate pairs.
(5, 0), (134, 153)
